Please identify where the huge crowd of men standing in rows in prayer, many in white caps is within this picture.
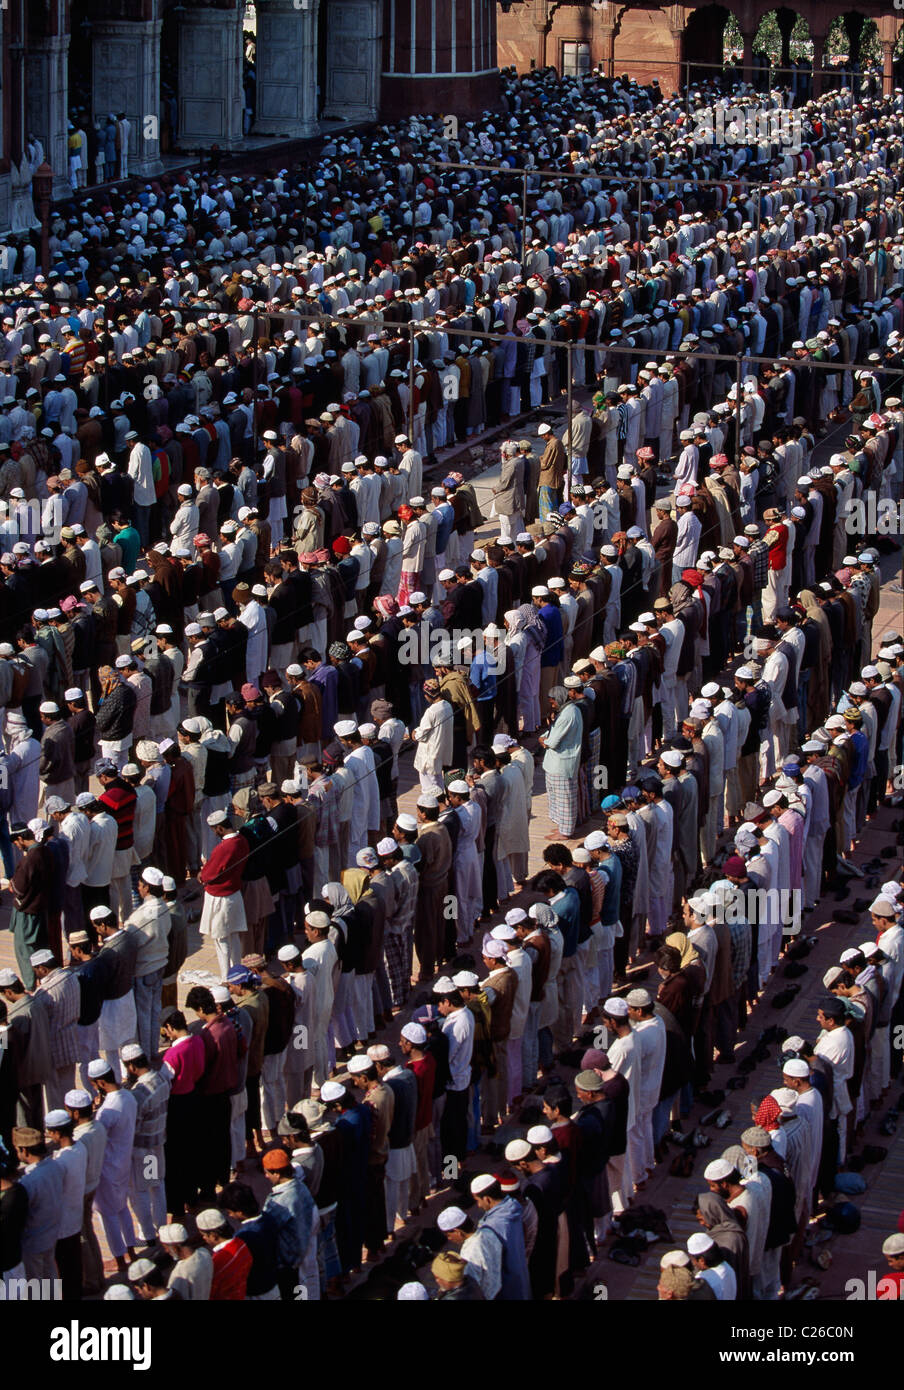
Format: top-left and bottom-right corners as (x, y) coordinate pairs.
(0, 62), (904, 1300)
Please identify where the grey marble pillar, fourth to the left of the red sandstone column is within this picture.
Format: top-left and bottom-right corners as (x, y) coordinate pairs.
(92, 19), (163, 178)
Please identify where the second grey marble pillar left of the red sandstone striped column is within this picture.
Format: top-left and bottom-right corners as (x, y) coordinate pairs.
(253, 0), (318, 140)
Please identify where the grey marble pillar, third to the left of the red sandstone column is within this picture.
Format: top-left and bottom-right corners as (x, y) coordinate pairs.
(177, 7), (245, 150)
